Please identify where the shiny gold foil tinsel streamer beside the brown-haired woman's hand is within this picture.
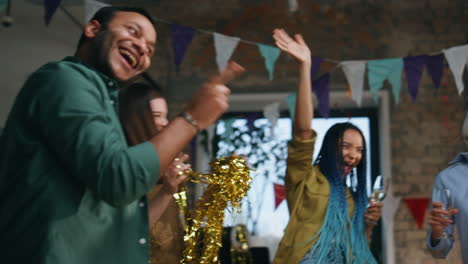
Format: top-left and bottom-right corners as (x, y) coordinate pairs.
(181, 156), (252, 264)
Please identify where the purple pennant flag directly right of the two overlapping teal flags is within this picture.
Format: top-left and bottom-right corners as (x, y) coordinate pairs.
(403, 55), (429, 103)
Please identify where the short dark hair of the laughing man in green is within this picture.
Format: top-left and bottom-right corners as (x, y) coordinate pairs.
(78, 6), (156, 48)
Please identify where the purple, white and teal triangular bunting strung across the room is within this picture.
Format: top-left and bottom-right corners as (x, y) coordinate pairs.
(44, 0), (468, 118)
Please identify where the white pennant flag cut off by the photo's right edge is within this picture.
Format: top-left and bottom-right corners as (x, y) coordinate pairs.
(443, 45), (468, 94)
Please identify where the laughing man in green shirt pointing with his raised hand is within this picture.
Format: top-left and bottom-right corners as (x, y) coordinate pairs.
(0, 7), (242, 264)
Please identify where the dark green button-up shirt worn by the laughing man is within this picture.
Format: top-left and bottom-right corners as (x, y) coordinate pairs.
(0, 57), (159, 264)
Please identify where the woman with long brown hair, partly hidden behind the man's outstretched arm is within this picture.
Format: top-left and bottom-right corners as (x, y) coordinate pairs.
(119, 83), (190, 264)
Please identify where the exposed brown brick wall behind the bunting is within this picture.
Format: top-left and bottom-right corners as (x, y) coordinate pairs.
(140, 0), (468, 264)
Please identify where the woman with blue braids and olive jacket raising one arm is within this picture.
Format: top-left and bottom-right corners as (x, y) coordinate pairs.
(273, 29), (382, 264)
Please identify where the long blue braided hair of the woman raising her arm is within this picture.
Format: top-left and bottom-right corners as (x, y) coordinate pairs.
(310, 122), (377, 264)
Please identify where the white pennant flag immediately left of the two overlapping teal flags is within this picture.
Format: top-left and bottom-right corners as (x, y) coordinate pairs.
(341, 61), (366, 106)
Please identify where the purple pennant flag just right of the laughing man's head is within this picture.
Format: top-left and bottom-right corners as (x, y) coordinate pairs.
(171, 24), (195, 71)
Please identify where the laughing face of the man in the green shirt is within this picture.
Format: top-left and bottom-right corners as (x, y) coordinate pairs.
(91, 12), (156, 82)
